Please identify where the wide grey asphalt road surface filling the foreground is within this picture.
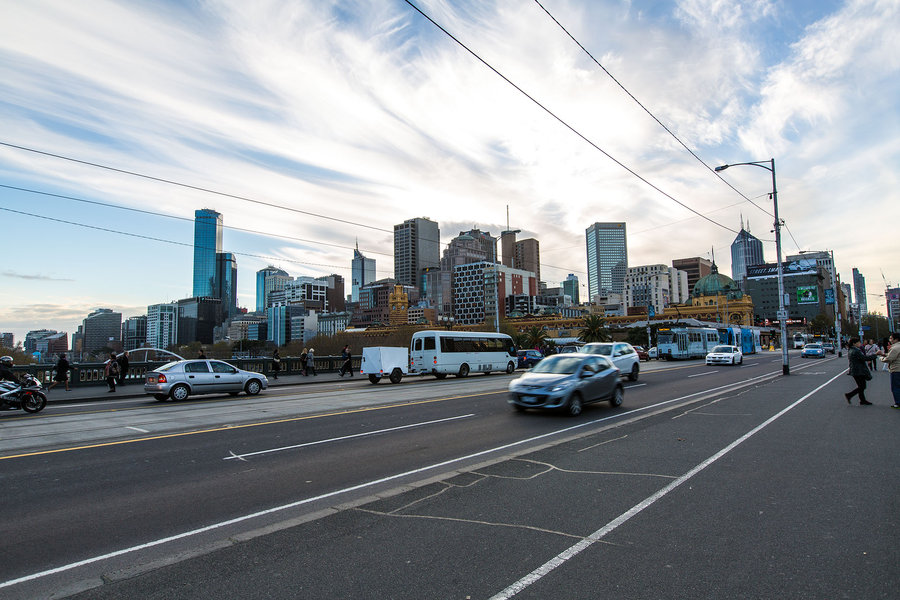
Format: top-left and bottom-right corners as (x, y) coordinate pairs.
(0, 354), (900, 598)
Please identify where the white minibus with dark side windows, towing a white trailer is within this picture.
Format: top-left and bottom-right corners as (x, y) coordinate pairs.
(409, 330), (516, 379)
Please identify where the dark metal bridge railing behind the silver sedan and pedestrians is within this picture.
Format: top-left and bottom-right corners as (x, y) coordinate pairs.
(13, 355), (360, 387)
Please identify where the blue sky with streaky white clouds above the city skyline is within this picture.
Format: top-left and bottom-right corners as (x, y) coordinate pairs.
(0, 0), (900, 341)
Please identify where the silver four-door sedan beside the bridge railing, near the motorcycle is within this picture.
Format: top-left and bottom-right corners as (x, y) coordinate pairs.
(144, 359), (269, 401)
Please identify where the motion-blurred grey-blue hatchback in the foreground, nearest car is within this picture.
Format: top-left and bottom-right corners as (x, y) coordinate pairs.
(509, 352), (625, 416)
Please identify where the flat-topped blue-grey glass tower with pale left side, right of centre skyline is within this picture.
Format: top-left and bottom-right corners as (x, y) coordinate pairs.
(585, 223), (628, 299)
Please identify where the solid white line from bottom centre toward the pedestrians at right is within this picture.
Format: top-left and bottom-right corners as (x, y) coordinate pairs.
(490, 373), (843, 600)
